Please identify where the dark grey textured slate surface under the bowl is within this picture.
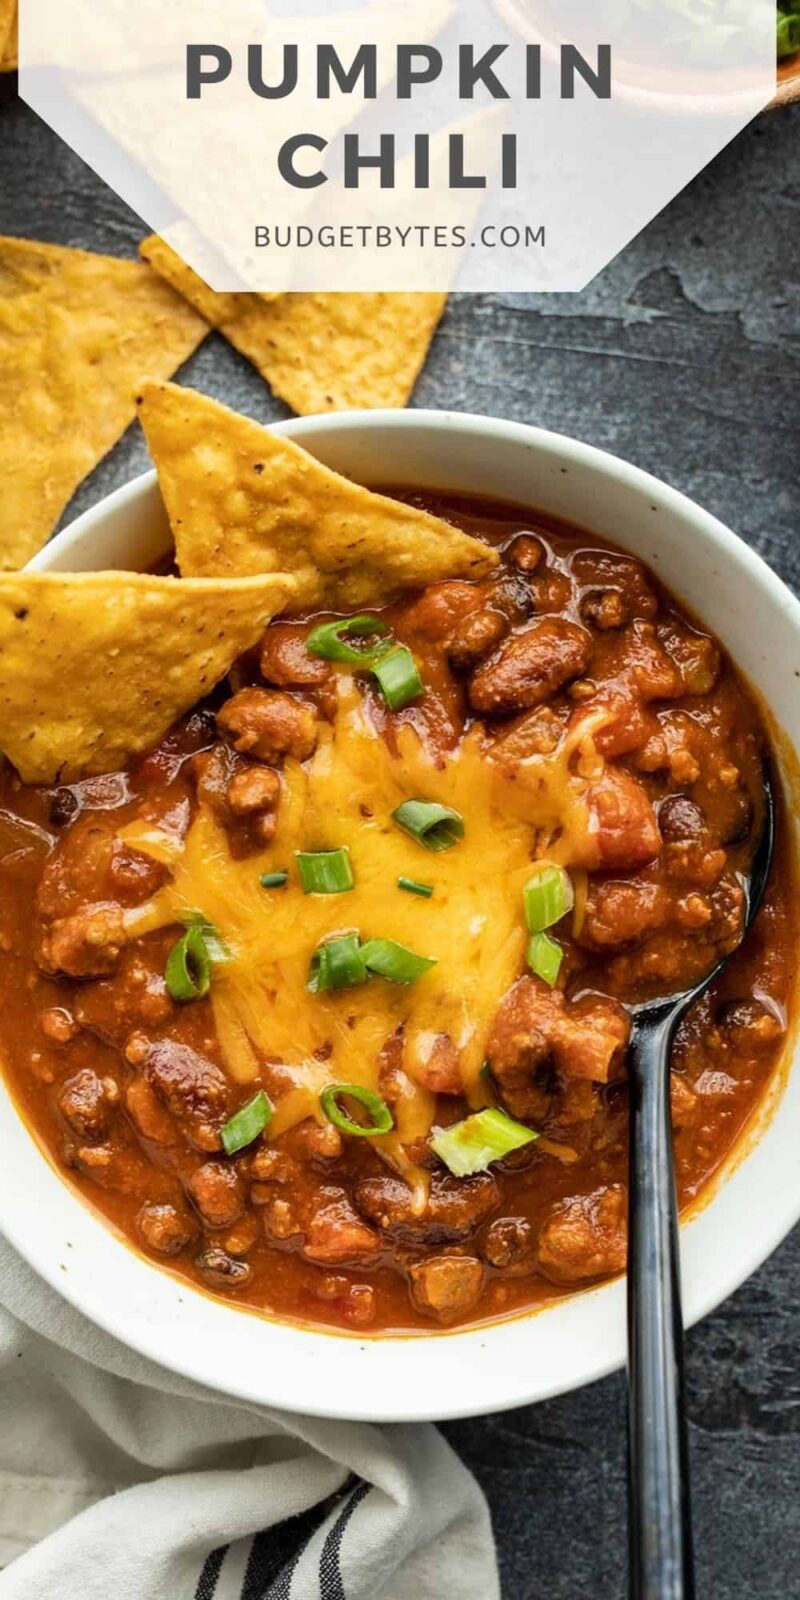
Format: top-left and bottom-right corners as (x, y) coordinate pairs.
(0, 78), (800, 1600)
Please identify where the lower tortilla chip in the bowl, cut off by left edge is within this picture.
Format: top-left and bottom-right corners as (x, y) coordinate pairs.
(0, 573), (294, 782)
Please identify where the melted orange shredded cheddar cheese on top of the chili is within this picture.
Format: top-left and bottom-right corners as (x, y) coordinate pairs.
(120, 675), (597, 1171)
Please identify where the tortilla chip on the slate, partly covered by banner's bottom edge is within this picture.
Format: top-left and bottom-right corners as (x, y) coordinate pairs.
(141, 234), (446, 416)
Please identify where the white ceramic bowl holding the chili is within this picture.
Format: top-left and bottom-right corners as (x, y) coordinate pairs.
(6, 411), (800, 1421)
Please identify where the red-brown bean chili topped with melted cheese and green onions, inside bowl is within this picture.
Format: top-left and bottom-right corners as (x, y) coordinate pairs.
(0, 490), (795, 1334)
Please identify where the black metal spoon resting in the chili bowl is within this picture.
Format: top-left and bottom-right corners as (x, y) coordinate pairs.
(627, 766), (774, 1600)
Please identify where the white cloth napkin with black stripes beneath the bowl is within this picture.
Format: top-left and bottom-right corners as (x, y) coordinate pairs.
(0, 1237), (499, 1600)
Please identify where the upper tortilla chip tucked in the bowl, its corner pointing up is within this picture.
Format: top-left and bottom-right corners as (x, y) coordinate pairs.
(139, 382), (498, 610)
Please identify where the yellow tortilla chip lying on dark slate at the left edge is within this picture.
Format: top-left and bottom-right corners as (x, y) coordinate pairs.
(0, 238), (208, 571)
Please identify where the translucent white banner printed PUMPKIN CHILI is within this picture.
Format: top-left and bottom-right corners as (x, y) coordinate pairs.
(19, 0), (776, 291)
